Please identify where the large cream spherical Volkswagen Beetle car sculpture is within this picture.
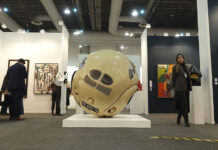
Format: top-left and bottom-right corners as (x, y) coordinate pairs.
(72, 50), (138, 117)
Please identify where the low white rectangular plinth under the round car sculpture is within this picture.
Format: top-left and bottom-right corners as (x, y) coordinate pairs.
(62, 114), (151, 128)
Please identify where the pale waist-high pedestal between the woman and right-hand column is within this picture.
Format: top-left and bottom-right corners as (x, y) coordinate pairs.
(189, 86), (205, 124)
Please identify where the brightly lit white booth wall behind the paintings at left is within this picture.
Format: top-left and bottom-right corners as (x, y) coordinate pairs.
(0, 31), (68, 113)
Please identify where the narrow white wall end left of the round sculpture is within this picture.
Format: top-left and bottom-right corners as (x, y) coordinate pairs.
(60, 25), (69, 114)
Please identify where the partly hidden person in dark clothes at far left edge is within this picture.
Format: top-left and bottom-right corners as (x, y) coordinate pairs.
(1, 75), (11, 115)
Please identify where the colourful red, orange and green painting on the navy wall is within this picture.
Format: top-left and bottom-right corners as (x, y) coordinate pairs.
(157, 64), (174, 98)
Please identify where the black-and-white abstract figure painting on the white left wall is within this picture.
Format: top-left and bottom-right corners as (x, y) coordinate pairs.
(34, 63), (58, 94)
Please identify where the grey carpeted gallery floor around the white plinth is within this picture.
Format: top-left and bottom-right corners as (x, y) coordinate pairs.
(0, 110), (218, 150)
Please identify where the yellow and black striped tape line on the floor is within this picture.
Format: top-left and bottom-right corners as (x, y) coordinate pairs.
(150, 136), (218, 142)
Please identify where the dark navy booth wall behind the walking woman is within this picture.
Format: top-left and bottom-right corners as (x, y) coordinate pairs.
(148, 36), (200, 113)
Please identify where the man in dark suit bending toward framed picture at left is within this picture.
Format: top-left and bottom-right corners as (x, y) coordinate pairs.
(7, 59), (27, 120)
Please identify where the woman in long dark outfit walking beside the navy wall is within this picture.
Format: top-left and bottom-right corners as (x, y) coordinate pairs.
(172, 54), (191, 127)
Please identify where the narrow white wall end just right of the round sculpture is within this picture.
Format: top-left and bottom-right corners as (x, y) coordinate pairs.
(141, 29), (148, 114)
